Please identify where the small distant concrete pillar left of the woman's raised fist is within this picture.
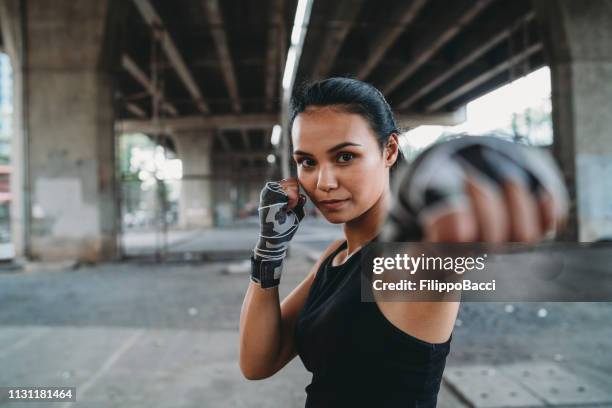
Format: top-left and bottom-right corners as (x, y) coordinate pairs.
(173, 130), (215, 228)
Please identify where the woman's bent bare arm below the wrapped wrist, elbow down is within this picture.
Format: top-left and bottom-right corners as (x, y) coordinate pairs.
(240, 240), (343, 380)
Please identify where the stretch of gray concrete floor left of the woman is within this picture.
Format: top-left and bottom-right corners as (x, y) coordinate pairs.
(0, 255), (316, 408)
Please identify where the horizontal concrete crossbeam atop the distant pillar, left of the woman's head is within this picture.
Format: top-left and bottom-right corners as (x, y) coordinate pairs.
(115, 113), (278, 133)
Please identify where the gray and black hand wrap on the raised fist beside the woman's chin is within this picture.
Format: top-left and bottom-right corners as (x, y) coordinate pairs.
(251, 181), (306, 288)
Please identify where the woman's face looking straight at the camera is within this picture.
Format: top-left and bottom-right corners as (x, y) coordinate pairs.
(291, 107), (395, 224)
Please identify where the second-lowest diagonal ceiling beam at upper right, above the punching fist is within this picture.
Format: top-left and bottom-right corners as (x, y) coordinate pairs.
(397, 10), (535, 109)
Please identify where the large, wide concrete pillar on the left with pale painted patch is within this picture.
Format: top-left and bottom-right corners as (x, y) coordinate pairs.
(4, 0), (123, 261)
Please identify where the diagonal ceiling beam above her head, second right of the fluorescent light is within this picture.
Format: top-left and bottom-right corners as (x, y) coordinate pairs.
(357, 0), (427, 81)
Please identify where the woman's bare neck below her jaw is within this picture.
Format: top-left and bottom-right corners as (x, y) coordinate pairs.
(344, 188), (391, 256)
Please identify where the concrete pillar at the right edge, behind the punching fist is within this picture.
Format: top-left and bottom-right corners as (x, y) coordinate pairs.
(534, 0), (612, 242)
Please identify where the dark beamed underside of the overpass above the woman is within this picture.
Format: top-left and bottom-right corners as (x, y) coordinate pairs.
(119, 0), (544, 118)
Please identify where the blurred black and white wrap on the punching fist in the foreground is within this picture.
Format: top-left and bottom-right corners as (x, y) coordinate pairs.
(378, 136), (568, 242)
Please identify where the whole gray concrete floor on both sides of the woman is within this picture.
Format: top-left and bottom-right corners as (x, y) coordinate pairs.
(0, 234), (612, 408)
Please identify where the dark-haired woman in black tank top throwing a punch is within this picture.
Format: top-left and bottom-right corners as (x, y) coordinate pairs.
(240, 78), (564, 407)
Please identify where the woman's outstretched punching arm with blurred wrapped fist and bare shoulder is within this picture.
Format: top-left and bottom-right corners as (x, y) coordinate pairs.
(378, 137), (568, 343)
